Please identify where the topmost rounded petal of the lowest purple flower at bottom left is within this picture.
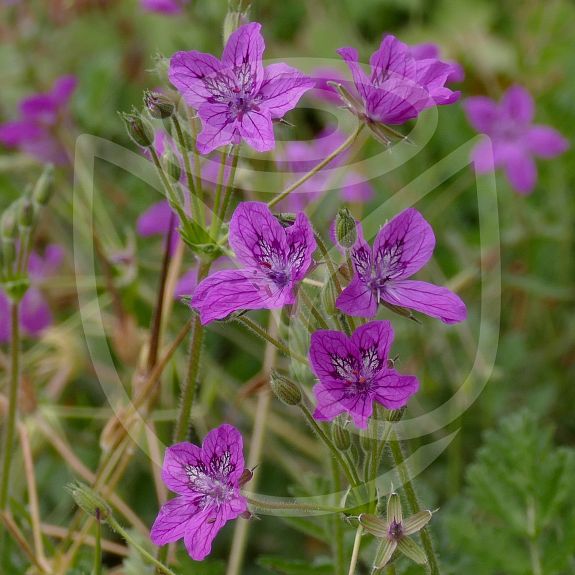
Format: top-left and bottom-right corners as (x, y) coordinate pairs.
(201, 424), (245, 483)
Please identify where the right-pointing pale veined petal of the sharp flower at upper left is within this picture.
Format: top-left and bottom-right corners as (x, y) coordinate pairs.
(260, 64), (315, 118)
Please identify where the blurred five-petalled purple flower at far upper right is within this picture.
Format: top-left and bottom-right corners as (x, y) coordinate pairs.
(464, 86), (569, 194)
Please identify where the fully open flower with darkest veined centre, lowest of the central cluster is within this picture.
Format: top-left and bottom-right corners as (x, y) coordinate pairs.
(309, 321), (419, 428)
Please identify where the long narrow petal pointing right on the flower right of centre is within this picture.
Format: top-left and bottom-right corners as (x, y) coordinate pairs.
(381, 280), (467, 323)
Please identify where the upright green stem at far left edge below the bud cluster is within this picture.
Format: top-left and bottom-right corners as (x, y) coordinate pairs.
(0, 301), (20, 511)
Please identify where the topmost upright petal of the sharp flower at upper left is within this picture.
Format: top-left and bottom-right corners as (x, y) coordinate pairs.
(222, 22), (265, 94)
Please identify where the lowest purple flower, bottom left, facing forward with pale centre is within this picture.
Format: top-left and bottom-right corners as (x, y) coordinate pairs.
(150, 425), (247, 561)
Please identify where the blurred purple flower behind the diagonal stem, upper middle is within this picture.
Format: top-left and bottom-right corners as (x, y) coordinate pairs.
(277, 129), (373, 212)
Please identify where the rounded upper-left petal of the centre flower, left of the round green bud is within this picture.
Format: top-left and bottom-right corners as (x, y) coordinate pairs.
(229, 202), (288, 267)
